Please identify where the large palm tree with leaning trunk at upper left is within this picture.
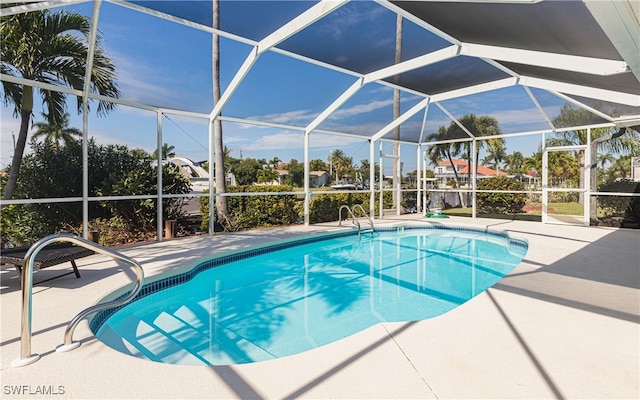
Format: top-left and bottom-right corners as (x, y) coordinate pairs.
(0, 6), (120, 200)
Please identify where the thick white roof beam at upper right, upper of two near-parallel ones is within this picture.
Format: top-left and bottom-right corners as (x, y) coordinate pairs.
(460, 43), (629, 76)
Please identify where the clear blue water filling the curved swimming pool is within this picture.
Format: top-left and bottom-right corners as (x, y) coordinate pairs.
(91, 229), (527, 365)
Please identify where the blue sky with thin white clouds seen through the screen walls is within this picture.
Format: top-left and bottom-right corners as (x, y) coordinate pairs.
(0, 2), (584, 172)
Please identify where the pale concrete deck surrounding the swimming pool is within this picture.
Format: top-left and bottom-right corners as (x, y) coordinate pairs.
(0, 214), (640, 399)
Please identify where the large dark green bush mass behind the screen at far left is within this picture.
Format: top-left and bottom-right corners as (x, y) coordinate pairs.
(0, 139), (189, 244)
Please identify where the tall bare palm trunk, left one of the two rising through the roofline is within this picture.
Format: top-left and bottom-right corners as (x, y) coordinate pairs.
(211, 0), (230, 222)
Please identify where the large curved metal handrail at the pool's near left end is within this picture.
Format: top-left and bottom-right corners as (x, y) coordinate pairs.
(11, 233), (144, 367)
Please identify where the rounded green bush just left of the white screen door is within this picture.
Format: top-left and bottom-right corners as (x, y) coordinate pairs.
(477, 176), (527, 214)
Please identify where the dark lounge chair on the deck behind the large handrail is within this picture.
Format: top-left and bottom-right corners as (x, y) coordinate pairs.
(0, 243), (94, 283)
